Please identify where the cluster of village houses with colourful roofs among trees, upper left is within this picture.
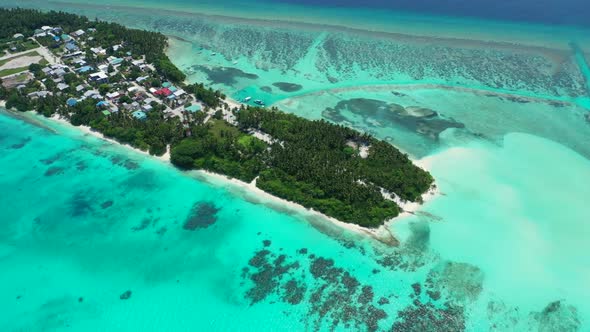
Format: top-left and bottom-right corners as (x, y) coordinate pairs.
(23, 26), (206, 120)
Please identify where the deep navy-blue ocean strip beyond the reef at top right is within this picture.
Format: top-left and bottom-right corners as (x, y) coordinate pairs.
(276, 0), (590, 26)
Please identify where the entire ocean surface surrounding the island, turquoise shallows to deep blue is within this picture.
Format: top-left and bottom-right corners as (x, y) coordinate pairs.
(0, 0), (590, 331)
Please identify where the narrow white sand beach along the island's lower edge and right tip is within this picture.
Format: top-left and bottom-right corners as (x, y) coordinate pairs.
(15, 107), (440, 246)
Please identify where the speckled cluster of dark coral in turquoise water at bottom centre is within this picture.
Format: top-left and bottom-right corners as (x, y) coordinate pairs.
(242, 249), (387, 331)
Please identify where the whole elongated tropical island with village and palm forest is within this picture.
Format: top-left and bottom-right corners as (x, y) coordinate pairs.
(0, 9), (434, 228)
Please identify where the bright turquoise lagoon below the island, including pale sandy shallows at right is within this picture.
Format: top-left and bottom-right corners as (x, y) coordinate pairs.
(0, 109), (590, 331)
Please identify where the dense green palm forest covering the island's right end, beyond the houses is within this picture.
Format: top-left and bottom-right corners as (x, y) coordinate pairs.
(172, 107), (433, 227)
